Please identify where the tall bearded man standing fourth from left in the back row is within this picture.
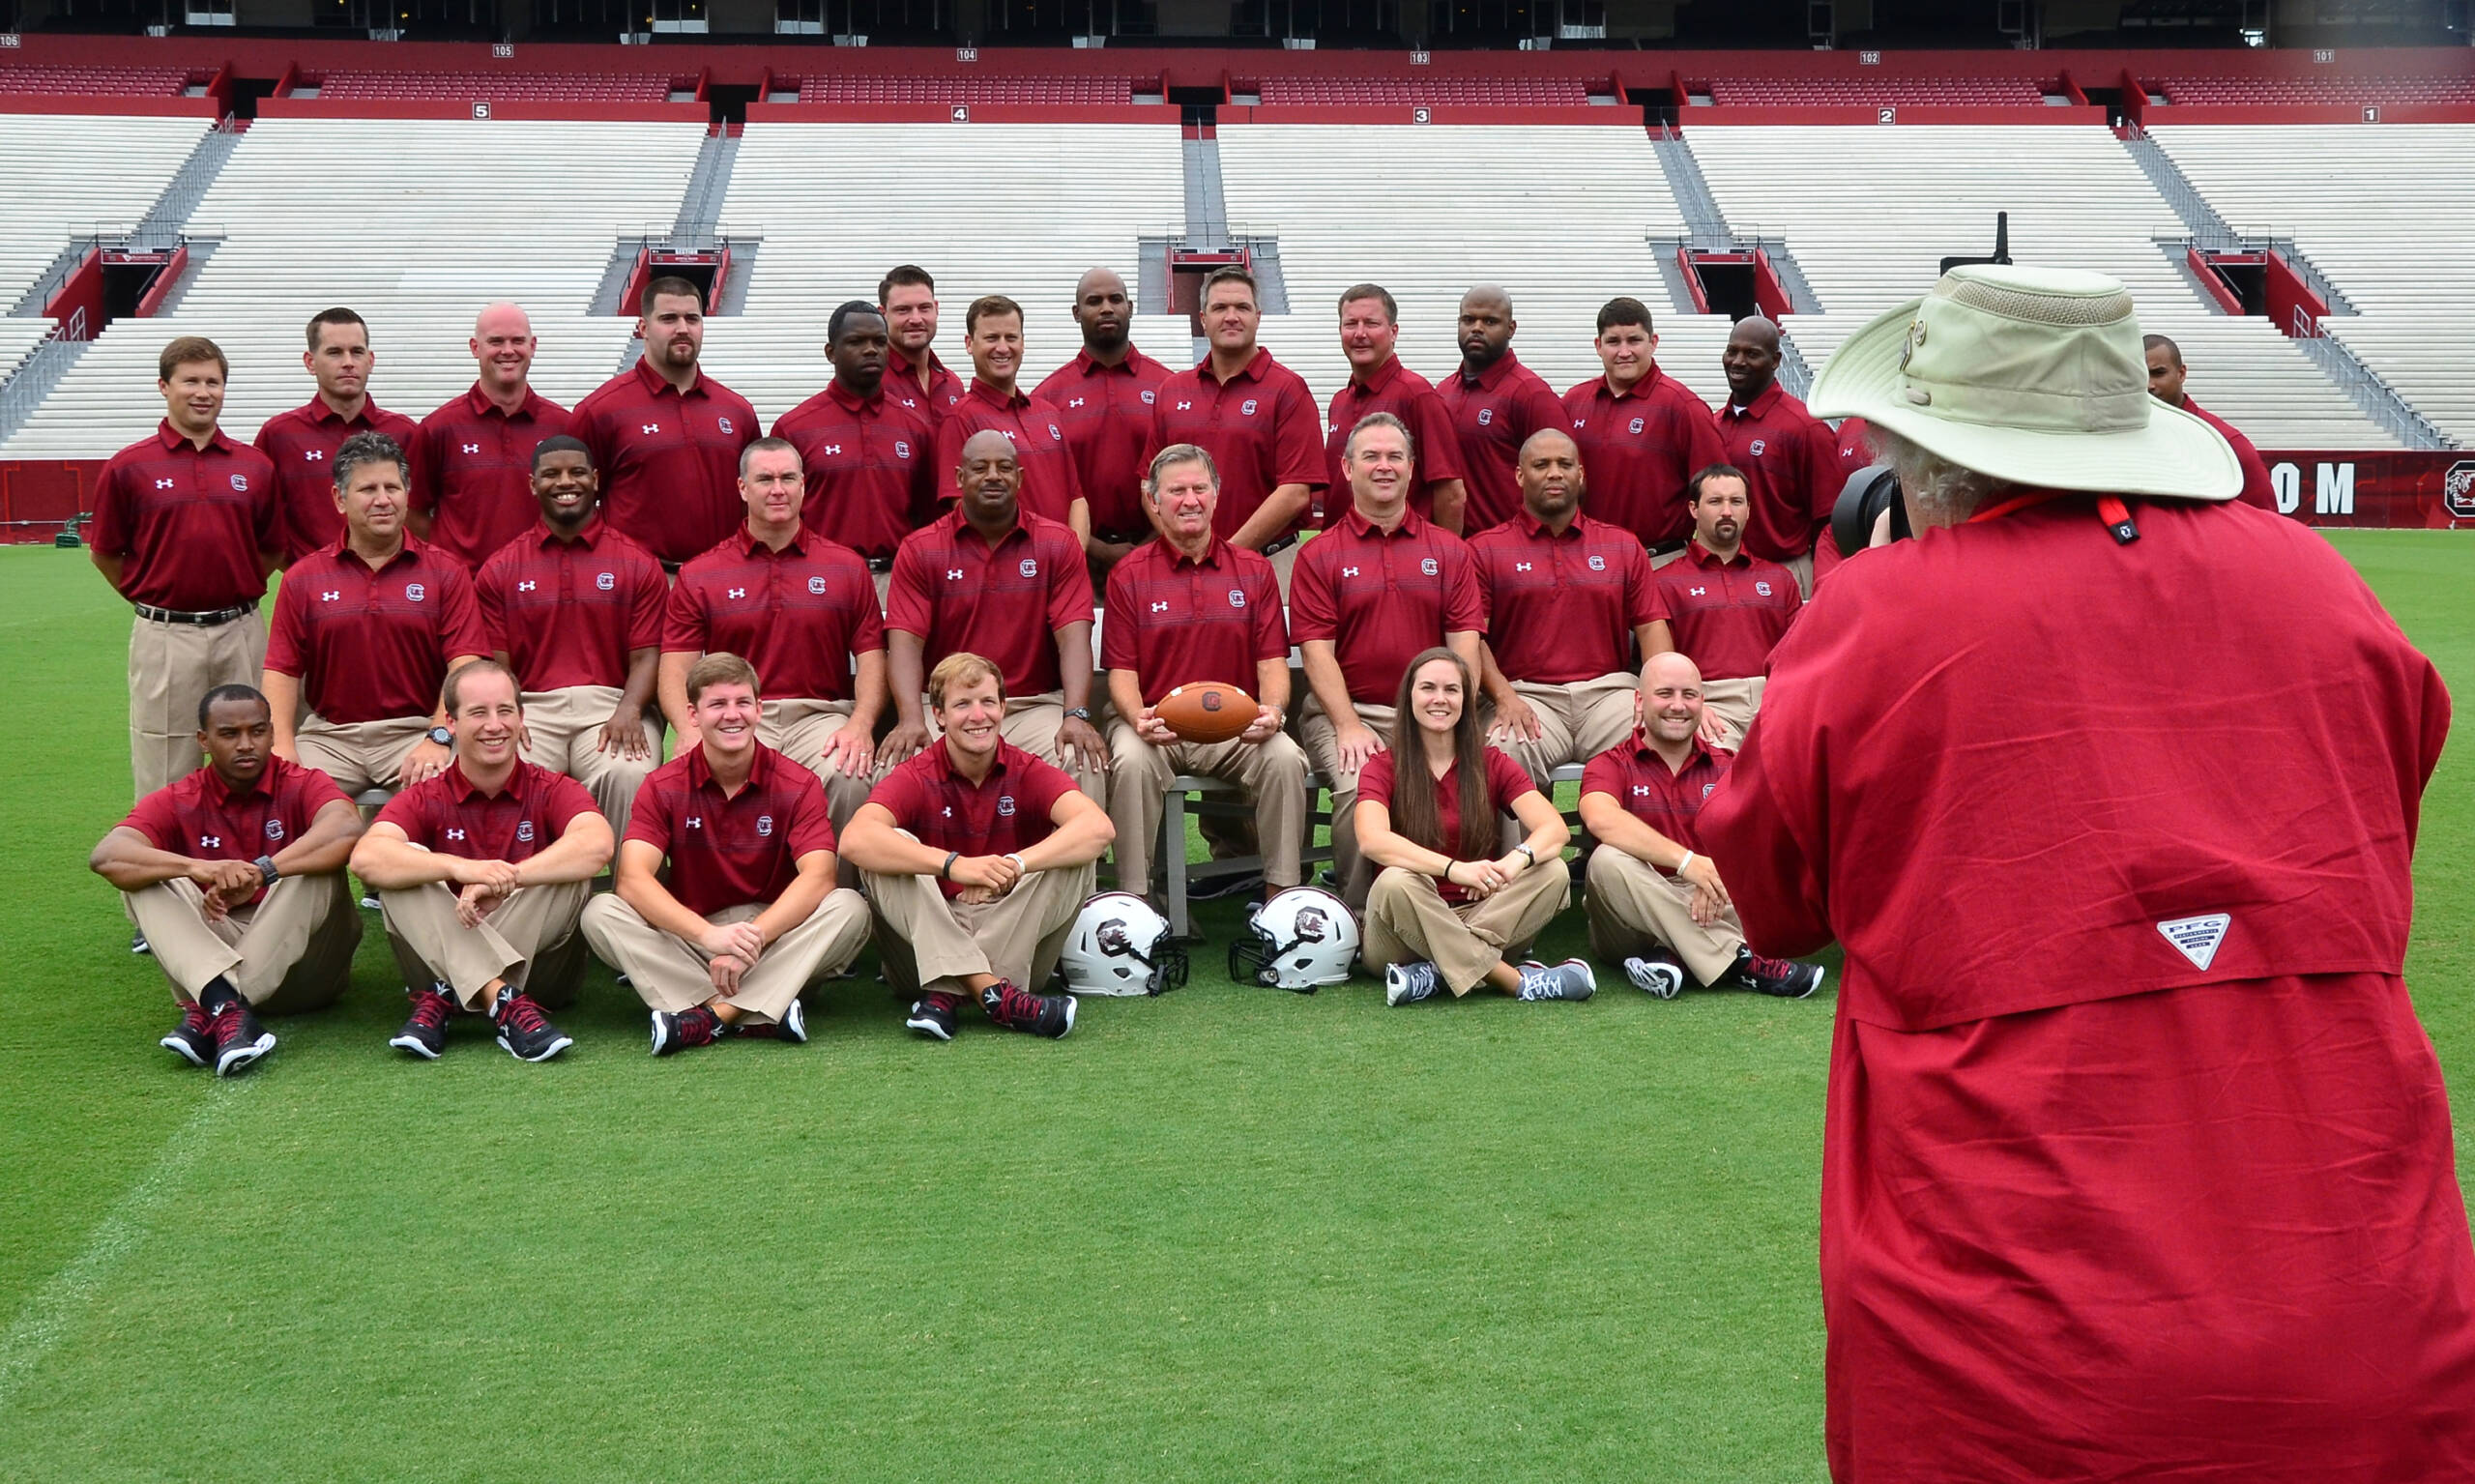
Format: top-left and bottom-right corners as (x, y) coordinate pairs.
(569, 277), (757, 571)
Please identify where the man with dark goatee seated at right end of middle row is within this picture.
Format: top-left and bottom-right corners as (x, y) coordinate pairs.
(1658, 465), (1804, 752)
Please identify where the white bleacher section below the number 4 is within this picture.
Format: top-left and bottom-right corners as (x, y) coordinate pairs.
(706, 124), (1193, 425)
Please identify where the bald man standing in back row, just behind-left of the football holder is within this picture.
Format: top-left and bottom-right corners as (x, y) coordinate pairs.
(1034, 267), (1168, 584)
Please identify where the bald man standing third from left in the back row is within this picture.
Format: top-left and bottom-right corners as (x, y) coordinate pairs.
(408, 305), (567, 571)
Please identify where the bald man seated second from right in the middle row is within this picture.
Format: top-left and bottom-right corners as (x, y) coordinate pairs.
(1470, 428), (1675, 789)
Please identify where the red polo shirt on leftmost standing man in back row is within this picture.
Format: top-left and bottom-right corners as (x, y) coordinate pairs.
(87, 421), (284, 613)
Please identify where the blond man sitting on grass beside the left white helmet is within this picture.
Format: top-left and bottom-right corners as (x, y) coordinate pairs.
(844, 651), (1117, 1041)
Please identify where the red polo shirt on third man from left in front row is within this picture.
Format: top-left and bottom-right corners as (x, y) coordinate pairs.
(626, 742), (834, 917)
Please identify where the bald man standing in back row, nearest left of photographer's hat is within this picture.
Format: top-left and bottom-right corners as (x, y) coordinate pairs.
(1718, 314), (1842, 597)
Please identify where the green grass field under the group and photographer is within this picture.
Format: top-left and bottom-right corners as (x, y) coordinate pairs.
(0, 532), (2475, 1484)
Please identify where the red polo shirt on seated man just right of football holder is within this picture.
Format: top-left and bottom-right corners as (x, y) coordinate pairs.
(1290, 507), (1488, 705)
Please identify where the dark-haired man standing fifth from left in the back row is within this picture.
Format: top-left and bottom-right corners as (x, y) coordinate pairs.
(772, 300), (936, 603)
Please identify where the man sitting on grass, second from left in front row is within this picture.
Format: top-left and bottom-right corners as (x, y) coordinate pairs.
(352, 660), (611, 1062)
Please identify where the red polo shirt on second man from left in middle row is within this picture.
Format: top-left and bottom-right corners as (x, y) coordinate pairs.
(473, 514), (671, 690)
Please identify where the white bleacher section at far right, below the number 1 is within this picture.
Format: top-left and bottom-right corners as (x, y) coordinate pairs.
(2151, 123), (2475, 446)
